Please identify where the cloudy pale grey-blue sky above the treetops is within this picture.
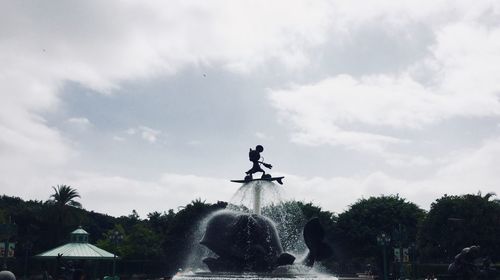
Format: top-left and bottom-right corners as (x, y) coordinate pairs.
(0, 0), (500, 217)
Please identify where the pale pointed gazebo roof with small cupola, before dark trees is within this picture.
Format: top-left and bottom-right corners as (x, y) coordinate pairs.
(35, 227), (118, 278)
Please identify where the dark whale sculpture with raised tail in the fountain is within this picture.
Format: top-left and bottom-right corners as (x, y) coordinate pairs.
(200, 211), (331, 272)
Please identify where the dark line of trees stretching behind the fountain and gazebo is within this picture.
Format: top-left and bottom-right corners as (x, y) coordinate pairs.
(0, 185), (500, 275)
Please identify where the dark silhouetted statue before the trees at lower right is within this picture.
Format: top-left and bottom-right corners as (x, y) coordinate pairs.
(448, 246), (480, 280)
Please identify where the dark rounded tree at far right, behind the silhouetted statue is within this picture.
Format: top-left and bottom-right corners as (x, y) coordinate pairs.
(418, 192), (500, 262)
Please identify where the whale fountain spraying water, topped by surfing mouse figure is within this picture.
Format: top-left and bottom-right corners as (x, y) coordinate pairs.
(174, 145), (337, 280)
